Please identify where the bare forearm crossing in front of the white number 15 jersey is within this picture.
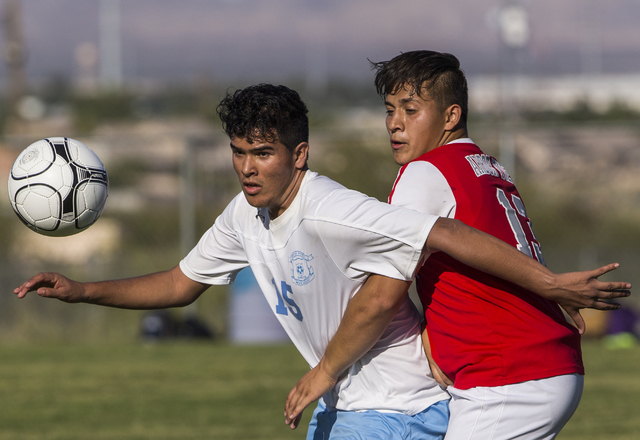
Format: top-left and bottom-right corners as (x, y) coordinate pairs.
(319, 275), (411, 378)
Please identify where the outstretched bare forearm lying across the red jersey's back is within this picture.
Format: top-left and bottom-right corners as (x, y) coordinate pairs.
(427, 218), (555, 296)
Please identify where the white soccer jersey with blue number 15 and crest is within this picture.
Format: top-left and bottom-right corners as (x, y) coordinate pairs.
(180, 171), (449, 415)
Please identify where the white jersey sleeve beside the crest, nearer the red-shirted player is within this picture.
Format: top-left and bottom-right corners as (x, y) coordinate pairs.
(316, 190), (438, 280)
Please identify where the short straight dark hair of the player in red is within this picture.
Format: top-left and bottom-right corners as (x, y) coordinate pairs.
(371, 50), (469, 124)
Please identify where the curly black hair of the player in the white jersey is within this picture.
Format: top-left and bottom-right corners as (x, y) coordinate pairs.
(216, 84), (309, 150)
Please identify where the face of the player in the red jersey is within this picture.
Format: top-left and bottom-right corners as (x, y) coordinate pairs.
(385, 87), (446, 165)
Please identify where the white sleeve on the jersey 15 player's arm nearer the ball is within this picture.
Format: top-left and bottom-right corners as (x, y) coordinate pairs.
(180, 195), (249, 285)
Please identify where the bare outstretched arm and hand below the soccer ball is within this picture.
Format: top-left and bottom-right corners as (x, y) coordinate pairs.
(14, 266), (209, 309)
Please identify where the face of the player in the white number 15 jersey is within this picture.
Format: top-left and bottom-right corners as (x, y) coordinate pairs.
(231, 138), (309, 219)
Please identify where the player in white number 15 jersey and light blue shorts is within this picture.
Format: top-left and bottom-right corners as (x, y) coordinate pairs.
(14, 84), (626, 439)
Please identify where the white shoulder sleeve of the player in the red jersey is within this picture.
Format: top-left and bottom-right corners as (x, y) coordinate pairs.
(390, 161), (456, 218)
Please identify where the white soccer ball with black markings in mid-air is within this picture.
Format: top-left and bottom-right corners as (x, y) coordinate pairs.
(9, 137), (109, 237)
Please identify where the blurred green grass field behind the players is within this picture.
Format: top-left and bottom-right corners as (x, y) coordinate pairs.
(0, 341), (640, 440)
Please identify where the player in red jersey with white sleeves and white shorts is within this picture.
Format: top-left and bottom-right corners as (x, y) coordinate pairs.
(286, 51), (628, 440)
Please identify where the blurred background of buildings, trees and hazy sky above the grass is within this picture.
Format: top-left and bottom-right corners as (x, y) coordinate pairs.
(0, 0), (640, 342)
